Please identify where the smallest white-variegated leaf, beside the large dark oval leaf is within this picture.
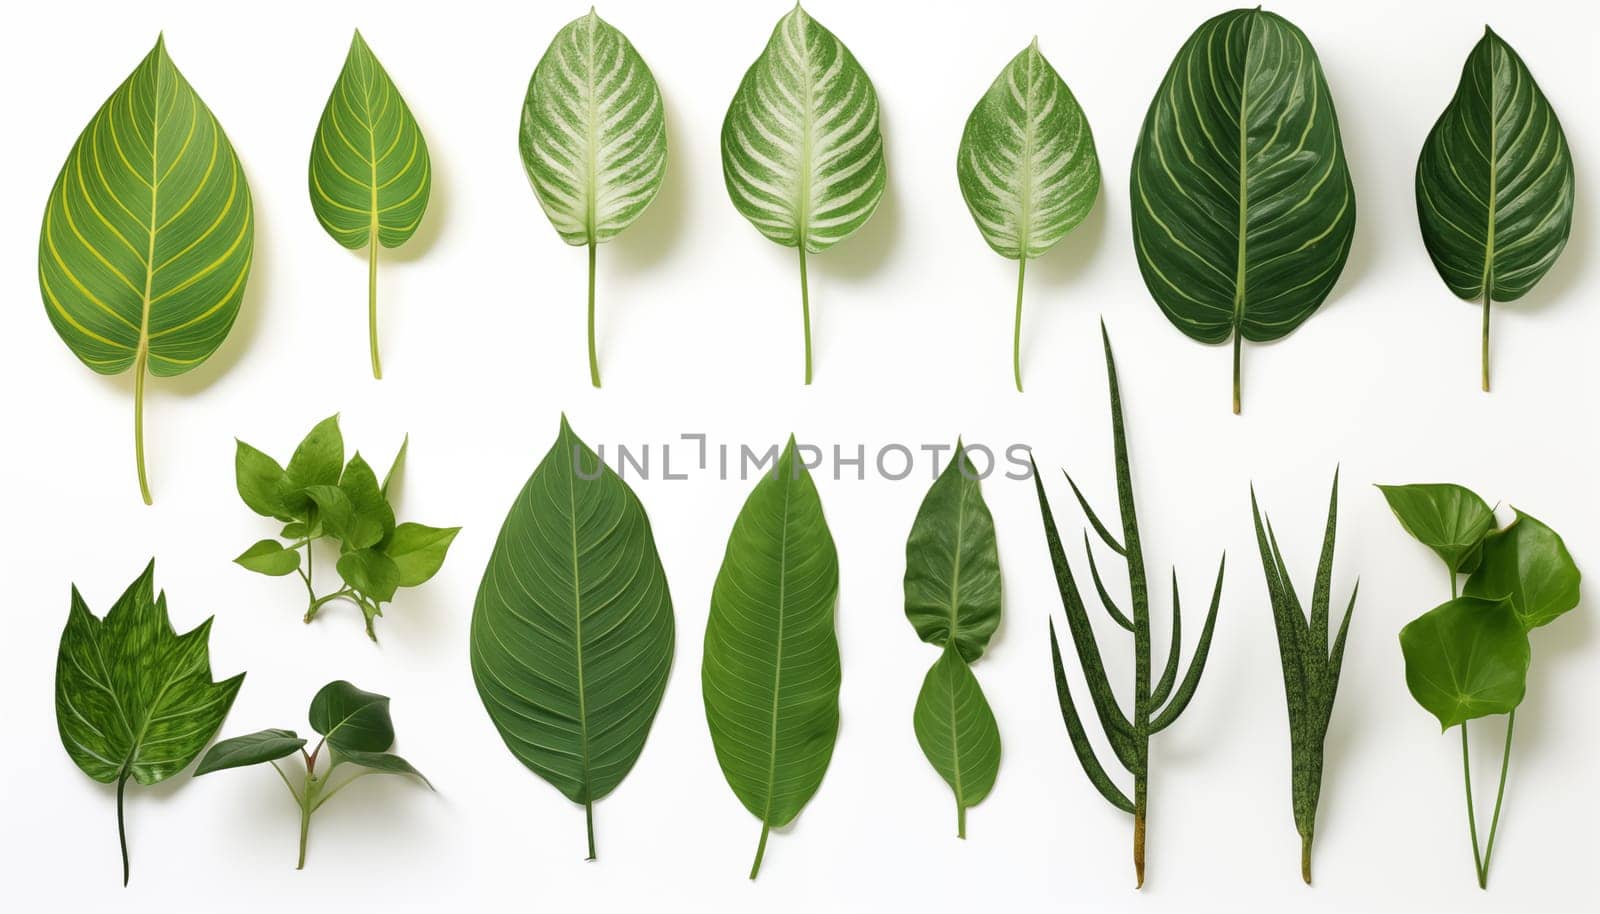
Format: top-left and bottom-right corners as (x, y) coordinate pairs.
(955, 38), (1099, 392)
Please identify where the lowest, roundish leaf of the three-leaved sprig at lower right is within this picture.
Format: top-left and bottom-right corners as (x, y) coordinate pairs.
(1400, 597), (1531, 730)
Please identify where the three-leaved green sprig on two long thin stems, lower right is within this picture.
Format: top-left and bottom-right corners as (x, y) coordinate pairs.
(1378, 483), (1579, 888)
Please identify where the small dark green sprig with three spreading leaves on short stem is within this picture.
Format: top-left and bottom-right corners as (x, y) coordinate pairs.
(195, 679), (434, 869)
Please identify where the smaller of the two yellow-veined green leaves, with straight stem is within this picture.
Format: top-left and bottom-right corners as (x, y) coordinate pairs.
(310, 30), (434, 378)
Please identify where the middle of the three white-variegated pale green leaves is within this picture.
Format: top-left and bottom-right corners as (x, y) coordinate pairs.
(722, 3), (885, 384)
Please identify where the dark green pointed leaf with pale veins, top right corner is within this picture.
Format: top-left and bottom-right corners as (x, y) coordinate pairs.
(1416, 27), (1573, 391)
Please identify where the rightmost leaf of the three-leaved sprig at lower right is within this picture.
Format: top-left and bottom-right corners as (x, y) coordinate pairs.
(1462, 511), (1579, 631)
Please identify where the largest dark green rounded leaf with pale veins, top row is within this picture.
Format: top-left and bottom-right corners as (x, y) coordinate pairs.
(1131, 8), (1355, 413)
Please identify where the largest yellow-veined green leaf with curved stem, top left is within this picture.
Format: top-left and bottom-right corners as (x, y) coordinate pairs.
(38, 38), (254, 504)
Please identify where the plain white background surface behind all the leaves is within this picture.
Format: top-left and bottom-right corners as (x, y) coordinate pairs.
(0, 0), (1600, 911)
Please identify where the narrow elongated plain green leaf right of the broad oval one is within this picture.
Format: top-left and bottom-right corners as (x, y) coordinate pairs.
(701, 437), (840, 879)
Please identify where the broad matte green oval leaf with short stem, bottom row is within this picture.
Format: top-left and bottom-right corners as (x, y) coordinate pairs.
(472, 416), (674, 858)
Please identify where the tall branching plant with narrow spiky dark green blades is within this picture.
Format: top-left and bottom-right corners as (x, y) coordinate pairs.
(1034, 323), (1227, 887)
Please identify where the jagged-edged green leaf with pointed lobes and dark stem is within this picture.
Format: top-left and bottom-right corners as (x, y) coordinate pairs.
(56, 562), (245, 885)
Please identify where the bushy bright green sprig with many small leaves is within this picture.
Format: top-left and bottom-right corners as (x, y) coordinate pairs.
(234, 416), (461, 640)
